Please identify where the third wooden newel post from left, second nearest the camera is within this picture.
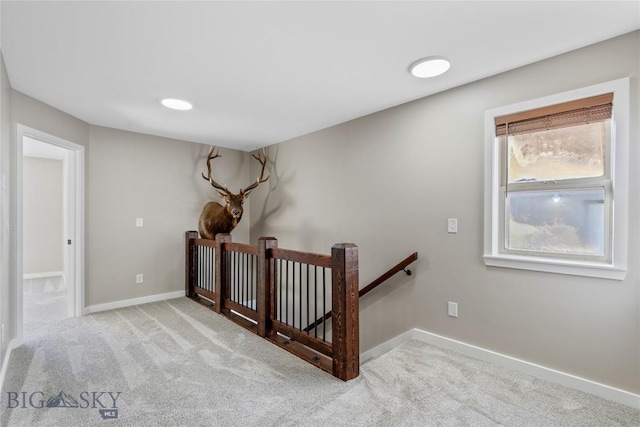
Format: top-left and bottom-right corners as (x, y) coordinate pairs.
(256, 237), (278, 337)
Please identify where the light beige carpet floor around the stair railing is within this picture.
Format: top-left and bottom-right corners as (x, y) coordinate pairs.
(0, 298), (640, 427)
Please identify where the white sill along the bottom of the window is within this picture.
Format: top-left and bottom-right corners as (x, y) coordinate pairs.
(484, 255), (627, 280)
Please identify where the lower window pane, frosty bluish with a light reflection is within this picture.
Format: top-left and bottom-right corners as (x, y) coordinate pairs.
(505, 188), (606, 256)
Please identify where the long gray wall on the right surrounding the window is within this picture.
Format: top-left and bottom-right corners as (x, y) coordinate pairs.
(251, 32), (640, 393)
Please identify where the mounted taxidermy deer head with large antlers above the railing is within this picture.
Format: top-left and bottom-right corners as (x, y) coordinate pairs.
(198, 146), (269, 240)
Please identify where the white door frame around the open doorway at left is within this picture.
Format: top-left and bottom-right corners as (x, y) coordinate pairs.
(15, 124), (85, 338)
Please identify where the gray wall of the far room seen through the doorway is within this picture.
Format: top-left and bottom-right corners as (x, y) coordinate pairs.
(22, 157), (63, 274)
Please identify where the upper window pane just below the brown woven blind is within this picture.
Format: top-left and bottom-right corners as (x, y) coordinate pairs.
(508, 120), (609, 183)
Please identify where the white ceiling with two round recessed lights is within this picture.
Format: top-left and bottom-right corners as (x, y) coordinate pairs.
(0, 1), (640, 151)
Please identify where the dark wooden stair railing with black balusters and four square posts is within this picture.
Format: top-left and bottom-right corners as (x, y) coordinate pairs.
(185, 231), (360, 381)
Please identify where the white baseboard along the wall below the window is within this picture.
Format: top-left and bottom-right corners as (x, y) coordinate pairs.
(360, 329), (640, 409)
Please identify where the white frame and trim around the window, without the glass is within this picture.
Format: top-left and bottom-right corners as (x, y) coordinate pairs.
(484, 78), (629, 280)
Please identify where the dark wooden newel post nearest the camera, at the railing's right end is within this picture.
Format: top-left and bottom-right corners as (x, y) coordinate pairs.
(331, 243), (360, 381)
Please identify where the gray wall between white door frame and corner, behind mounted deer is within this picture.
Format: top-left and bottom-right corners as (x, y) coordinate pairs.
(85, 126), (250, 306)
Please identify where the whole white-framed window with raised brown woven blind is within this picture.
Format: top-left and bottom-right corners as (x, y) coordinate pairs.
(484, 79), (629, 279)
